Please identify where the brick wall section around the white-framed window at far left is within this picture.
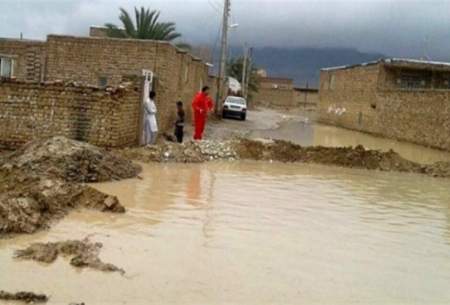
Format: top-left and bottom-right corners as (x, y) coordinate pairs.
(0, 38), (45, 82)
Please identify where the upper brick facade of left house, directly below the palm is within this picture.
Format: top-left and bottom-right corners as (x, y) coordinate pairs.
(46, 35), (165, 86)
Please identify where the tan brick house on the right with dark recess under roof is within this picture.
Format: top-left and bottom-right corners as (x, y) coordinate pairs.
(318, 58), (450, 150)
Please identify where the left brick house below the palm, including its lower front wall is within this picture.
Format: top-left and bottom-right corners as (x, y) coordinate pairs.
(0, 31), (214, 146)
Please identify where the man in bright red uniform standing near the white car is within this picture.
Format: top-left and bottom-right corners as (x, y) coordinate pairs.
(192, 86), (214, 140)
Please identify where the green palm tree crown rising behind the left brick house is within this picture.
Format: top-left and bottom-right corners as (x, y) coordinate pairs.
(105, 7), (189, 49)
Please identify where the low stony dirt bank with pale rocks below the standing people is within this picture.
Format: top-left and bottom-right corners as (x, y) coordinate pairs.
(117, 141), (237, 163)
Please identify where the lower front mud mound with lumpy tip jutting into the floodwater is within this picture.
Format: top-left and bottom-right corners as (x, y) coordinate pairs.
(0, 168), (125, 236)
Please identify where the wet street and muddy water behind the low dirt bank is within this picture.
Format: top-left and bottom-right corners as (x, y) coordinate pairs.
(193, 109), (450, 164)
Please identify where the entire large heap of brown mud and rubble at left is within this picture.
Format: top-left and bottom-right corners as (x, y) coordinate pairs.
(0, 137), (140, 237)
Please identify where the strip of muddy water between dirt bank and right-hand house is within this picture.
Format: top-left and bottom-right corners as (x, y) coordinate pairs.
(252, 121), (450, 163)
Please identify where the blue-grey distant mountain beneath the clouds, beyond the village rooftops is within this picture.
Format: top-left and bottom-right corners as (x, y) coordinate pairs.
(239, 47), (386, 87)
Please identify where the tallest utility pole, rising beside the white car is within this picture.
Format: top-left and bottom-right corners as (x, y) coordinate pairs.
(215, 0), (230, 115)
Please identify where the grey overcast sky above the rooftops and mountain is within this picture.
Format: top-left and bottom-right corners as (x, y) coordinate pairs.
(0, 0), (450, 59)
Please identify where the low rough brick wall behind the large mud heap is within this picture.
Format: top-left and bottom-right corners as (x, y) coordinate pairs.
(0, 81), (140, 148)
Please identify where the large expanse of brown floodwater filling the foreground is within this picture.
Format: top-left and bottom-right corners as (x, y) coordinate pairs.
(0, 162), (450, 305)
